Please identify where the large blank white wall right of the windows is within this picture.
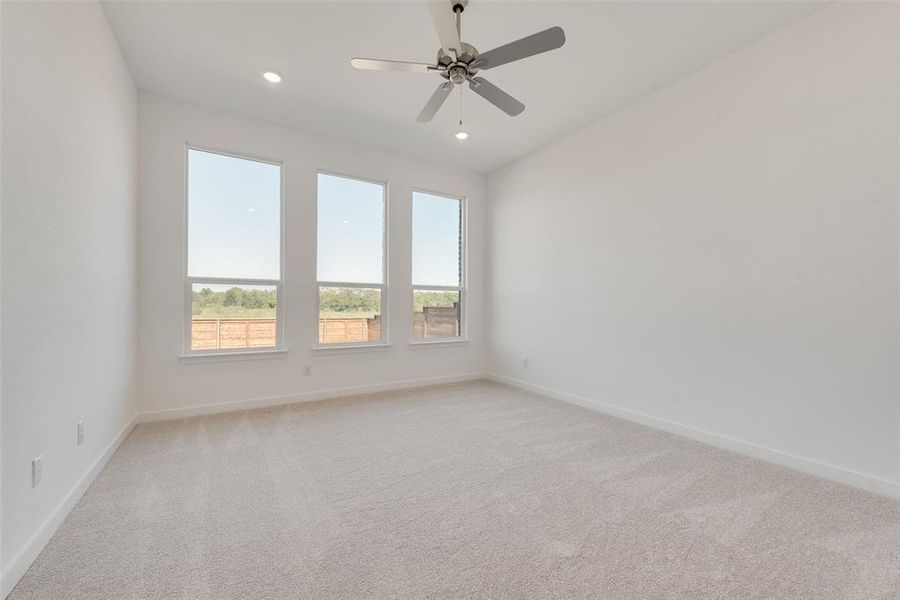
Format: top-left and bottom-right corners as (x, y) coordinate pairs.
(487, 3), (900, 491)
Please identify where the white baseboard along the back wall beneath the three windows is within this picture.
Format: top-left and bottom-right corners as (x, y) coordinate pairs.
(138, 373), (487, 423)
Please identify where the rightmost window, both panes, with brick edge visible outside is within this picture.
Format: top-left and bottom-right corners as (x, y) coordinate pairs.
(412, 192), (466, 340)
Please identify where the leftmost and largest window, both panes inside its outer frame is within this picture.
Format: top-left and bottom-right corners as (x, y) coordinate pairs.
(185, 148), (282, 353)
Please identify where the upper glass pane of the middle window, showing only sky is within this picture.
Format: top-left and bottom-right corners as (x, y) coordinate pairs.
(318, 173), (384, 283)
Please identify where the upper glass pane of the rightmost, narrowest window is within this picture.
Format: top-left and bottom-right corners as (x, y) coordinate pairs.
(412, 192), (462, 286)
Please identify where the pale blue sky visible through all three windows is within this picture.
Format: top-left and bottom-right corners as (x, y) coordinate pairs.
(188, 150), (460, 286)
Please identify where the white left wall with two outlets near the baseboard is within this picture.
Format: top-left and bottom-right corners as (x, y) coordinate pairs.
(2, 2), (137, 593)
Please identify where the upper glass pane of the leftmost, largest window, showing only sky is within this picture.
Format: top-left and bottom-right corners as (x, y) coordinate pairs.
(188, 150), (281, 279)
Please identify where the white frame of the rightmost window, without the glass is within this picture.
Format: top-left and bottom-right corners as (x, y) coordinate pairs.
(409, 187), (469, 346)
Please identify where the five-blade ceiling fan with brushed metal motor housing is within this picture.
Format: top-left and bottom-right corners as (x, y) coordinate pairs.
(350, 0), (566, 123)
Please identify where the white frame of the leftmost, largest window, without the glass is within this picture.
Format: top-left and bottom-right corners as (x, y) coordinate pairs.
(182, 143), (286, 357)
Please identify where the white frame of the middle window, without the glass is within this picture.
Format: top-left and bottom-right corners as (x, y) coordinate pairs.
(313, 169), (390, 352)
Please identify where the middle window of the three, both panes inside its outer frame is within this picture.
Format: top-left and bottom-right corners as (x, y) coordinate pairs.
(317, 173), (387, 346)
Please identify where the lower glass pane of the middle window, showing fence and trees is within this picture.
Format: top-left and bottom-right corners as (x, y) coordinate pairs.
(319, 287), (381, 344)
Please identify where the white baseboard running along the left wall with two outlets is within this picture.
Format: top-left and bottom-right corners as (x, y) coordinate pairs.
(0, 416), (137, 598)
